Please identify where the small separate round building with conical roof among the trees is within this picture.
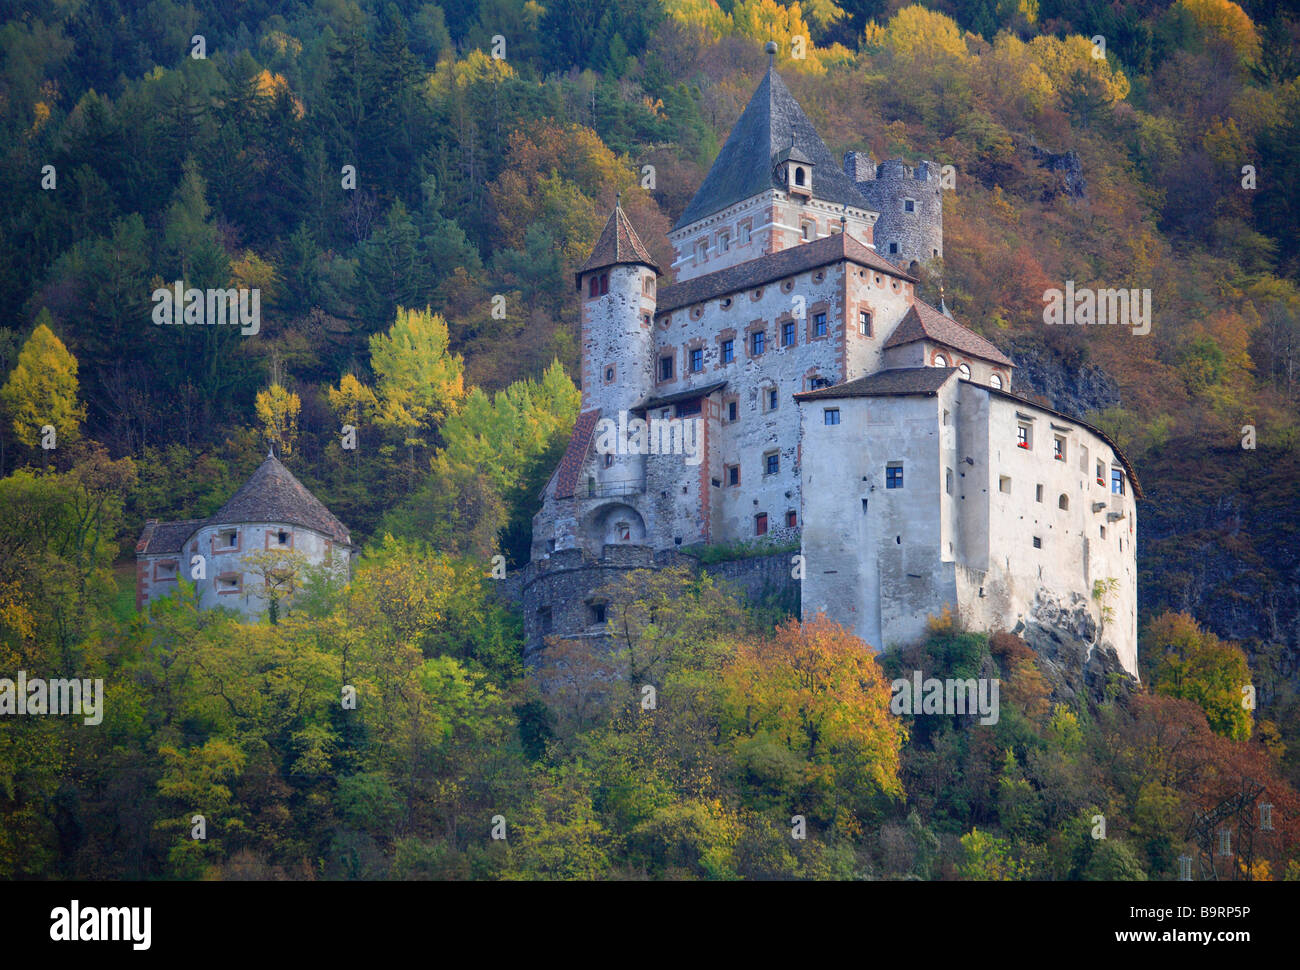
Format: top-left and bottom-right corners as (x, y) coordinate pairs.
(135, 455), (354, 619)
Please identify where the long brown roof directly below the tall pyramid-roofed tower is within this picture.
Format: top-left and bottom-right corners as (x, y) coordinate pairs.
(655, 233), (917, 313)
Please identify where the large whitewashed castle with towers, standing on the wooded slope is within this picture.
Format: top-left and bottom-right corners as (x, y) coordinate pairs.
(520, 46), (1141, 675)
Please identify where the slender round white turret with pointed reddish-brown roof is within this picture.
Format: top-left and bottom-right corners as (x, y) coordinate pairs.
(573, 203), (659, 419)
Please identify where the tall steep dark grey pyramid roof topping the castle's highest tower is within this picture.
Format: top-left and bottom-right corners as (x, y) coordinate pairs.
(673, 66), (872, 230)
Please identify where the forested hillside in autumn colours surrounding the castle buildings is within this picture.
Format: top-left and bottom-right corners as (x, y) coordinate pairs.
(0, 0), (1300, 878)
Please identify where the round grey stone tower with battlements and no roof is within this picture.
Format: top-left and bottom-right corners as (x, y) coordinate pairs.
(844, 152), (944, 273)
